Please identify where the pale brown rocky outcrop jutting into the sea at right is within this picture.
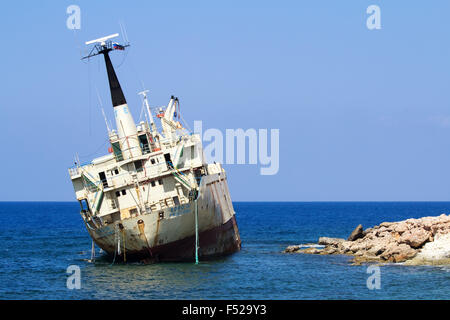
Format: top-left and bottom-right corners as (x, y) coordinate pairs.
(284, 214), (450, 264)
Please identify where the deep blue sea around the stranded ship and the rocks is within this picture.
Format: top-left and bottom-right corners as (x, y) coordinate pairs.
(0, 202), (450, 299)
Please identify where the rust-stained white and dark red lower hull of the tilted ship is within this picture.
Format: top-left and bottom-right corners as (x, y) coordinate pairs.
(86, 177), (241, 262)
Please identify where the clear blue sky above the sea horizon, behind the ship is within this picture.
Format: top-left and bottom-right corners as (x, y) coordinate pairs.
(0, 0), (450, 201)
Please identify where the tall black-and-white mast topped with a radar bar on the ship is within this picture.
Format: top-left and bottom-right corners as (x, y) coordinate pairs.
(83, 33), (141, 159)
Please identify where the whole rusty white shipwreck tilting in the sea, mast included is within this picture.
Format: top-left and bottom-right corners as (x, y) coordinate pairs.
(69, 34), (241, 261)
